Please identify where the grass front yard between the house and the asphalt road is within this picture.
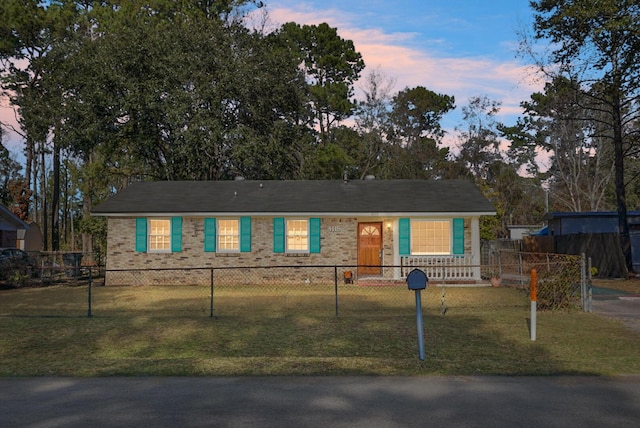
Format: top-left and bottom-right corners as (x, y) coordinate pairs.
(0, 286), (640, 376)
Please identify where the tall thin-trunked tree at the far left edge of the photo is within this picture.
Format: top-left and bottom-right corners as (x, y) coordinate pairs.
(0, 0), (84, 250)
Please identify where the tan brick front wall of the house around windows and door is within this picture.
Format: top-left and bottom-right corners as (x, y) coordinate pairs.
(106, 217), (471, 285)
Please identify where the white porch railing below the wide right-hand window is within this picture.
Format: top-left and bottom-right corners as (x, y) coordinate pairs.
(400, 254), (480, 281)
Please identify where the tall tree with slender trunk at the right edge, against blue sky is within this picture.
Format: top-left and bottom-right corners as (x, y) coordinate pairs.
(531, 0), (640, 269)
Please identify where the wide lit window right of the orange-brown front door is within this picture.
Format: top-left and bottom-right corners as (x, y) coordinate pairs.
(411, 220), (452, 255)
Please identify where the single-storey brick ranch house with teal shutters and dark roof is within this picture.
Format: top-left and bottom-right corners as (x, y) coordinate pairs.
(92, 179), (495, 285)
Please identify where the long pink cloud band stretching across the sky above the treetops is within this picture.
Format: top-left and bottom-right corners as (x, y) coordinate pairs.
(262, 3), (542, 121)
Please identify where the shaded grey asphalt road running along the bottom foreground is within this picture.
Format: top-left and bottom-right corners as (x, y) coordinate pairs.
(0, 376), (640, 428)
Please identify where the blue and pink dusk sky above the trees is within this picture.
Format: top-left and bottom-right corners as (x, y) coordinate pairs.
(0, 0), (542, 164)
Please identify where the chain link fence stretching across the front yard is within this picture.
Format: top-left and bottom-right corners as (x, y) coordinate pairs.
(0, 251), (589, 317)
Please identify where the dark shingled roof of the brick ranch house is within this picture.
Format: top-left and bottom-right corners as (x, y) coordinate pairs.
(92, 180), (495, 216)
